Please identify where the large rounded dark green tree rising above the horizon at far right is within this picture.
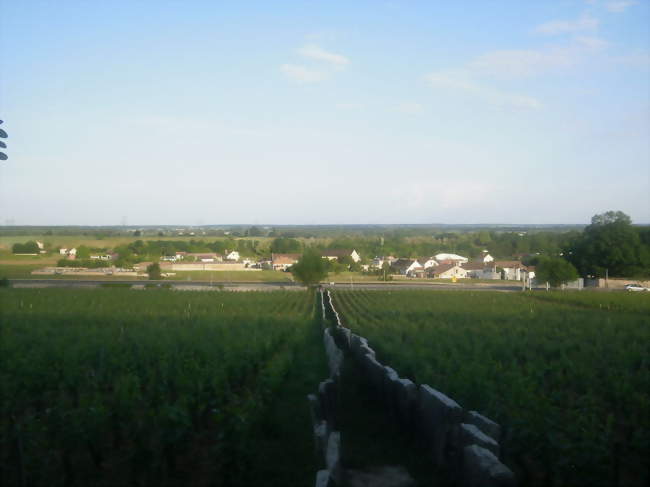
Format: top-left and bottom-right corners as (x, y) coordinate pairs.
(566, 211), (650, 277)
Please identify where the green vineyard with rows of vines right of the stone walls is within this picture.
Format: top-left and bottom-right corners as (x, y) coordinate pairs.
(334, 291), (650, 486)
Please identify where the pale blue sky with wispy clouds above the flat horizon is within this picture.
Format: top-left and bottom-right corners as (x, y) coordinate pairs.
(0, 0), (650, 225)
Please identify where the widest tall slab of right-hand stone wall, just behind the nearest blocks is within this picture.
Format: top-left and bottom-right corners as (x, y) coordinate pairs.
(417, 384), (463, 467)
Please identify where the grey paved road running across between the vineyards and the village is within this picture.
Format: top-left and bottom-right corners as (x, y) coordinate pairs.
(9, 279), (521, 292)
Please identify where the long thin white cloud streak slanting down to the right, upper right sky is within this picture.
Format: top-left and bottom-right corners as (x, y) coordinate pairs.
(426, 71), (542, 110)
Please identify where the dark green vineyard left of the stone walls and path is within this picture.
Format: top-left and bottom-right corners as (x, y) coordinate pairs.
(0, 289), (325, 485)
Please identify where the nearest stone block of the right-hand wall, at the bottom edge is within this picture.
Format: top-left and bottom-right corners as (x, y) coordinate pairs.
(460, 445), (516, 487)
